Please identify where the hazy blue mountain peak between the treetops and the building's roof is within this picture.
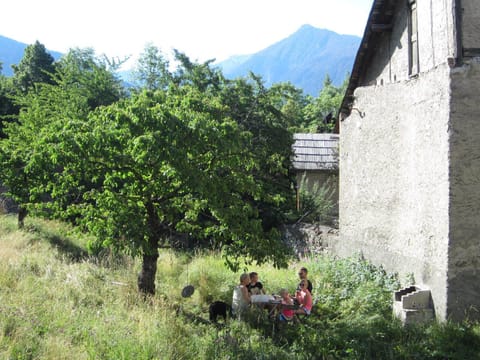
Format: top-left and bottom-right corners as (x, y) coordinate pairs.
(217, 25), (361, 96)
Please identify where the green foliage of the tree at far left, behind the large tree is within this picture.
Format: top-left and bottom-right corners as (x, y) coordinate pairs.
(0, 50), (125, 224)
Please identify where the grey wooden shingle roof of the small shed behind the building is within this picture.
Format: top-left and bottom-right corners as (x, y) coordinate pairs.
(293, 134), (340, 170)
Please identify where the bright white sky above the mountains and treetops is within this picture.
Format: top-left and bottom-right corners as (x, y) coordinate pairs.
(0, 0), (373, 62)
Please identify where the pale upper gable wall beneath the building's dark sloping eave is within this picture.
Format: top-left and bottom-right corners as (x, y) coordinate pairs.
(361, 0), (455, 85)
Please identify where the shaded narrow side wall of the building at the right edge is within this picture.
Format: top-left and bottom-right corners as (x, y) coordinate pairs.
(448, 62), (480, 319)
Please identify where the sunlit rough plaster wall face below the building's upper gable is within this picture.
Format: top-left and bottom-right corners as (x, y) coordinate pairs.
(340, 65), (449, 318)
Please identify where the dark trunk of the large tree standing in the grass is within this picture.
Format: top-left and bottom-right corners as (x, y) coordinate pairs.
(137, 202), (164, 295)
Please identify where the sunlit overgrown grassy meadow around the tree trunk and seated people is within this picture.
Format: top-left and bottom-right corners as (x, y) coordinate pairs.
(0, 216), (480, 360)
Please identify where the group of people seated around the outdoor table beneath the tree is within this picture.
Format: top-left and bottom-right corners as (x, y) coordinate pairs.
(232, 267), (313, 321)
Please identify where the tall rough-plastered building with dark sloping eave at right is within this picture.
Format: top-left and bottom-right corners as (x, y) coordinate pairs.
(333, 0), (480, 320)
